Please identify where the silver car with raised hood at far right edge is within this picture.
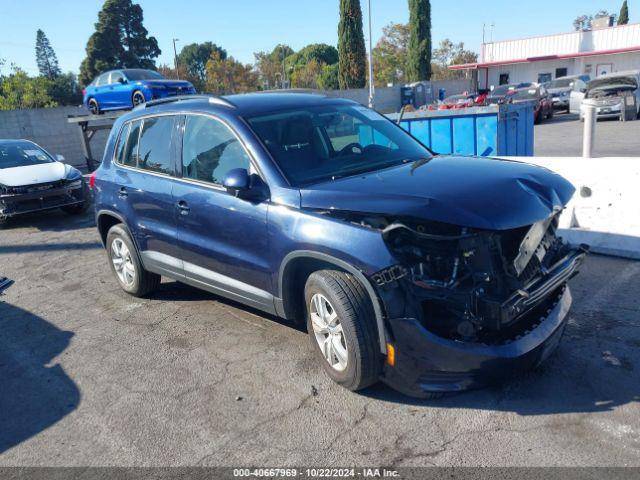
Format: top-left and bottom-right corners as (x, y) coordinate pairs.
(580, 70), (640, 120)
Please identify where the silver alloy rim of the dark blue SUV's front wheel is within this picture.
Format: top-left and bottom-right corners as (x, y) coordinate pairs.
(309, 293), (348, 372)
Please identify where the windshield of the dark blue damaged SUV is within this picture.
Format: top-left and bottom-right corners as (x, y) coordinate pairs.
(248, 105), (432, 186)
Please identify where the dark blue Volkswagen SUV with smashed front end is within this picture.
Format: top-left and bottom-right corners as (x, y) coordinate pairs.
(91, 94), (585, 397)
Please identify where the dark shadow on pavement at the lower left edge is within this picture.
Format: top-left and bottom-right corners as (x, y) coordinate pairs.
(0, 301), (80, 453)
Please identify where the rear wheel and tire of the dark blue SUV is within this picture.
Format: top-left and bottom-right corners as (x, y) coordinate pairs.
(106, 224), (161, 297)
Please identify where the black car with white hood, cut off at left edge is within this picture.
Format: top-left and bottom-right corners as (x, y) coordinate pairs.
(0, 140), (89, 225)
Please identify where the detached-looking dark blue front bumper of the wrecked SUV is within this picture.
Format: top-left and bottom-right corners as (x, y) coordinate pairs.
(383, 251), (585, 397)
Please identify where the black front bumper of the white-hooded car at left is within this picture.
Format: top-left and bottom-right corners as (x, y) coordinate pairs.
(0, 184), (86, 217)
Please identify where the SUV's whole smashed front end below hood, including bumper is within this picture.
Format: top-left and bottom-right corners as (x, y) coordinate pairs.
(322, 207), (587, 396)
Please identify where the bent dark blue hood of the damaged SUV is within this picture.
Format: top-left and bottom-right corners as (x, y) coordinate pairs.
(301, 156), (575, 230)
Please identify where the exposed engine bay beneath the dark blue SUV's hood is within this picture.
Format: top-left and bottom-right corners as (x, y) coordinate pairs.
(322, 210), (586, 344)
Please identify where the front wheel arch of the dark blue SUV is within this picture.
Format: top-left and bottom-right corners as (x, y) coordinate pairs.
(276, 250), (387, 355)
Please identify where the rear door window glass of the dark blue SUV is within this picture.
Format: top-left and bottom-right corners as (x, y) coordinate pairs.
(138, 116), (175, 175)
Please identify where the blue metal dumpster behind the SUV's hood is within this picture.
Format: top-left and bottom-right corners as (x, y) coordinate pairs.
(387, 102), (534, 157)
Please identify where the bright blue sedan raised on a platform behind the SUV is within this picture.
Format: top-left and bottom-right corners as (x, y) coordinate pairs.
(82, 68), (196, 115)
